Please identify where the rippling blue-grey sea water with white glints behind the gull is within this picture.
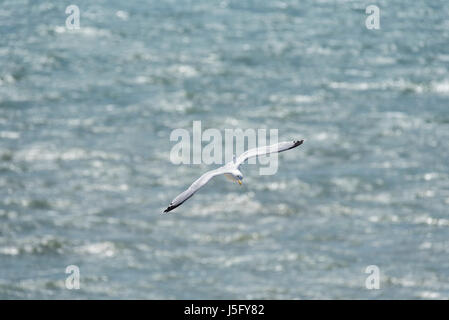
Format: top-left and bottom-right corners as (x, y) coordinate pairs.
(0, 0), (449, 299)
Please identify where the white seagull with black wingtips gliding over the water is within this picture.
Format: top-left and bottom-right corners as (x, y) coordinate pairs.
(164, 140), (304, 213)
